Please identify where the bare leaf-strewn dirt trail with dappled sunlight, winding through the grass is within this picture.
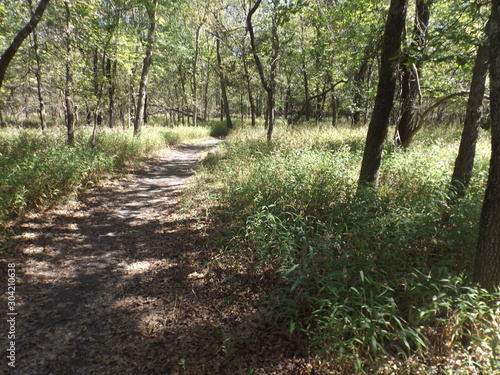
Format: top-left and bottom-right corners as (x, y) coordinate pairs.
(0, 140), (314, 375)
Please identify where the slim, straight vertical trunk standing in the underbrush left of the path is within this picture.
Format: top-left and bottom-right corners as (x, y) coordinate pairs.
(64, 1), (75, 145)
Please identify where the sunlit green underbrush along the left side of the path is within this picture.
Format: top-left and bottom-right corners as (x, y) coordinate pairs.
(0, 127), (209, 222)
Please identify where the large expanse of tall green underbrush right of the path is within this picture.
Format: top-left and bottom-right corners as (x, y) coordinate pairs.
(189, 127), (500, 374)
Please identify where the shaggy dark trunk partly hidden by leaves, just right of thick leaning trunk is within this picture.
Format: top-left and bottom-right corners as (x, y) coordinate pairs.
(394, 0), (433, 148)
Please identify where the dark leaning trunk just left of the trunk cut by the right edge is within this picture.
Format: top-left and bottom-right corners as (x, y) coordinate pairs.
(450, 45), (490, 202)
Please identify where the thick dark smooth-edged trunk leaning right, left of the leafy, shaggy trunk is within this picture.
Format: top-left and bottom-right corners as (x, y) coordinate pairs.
(359, 0), (408, 186)
